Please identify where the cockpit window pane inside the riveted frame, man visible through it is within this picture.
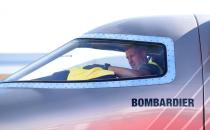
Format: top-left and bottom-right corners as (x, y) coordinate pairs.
(19, 39), (167, 81)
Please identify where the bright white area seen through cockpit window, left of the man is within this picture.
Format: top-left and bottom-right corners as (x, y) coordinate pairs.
(21, 48), (129, 81)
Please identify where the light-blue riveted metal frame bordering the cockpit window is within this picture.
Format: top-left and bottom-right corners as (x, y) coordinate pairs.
(0, 33), (176, 88)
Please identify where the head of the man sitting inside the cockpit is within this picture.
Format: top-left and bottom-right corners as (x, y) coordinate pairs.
(125, 46), (147, 70)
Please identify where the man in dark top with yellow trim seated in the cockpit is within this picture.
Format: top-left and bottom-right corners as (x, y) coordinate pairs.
(100, 46), (163, 78)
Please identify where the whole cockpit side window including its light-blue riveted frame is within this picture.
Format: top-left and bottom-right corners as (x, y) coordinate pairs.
(4, 34), (175, 88)
